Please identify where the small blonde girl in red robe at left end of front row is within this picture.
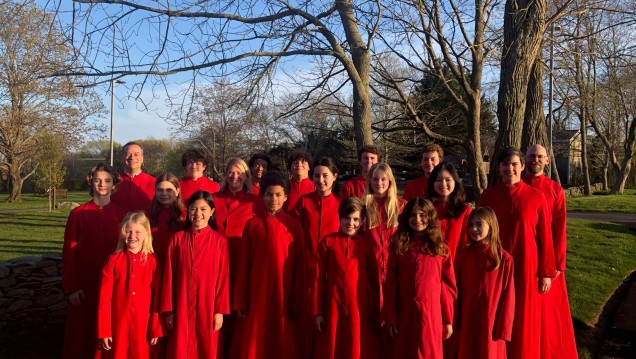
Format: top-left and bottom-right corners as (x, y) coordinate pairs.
(95, 212), (163, 359)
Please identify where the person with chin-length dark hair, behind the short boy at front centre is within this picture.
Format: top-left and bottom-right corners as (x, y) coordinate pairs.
(294, 157), (340, 358)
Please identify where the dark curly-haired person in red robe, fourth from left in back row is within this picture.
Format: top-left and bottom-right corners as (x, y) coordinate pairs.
(285, 149), (316, 213)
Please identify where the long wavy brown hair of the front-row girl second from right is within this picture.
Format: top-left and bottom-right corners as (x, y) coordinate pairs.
(393, 197), (448, 256)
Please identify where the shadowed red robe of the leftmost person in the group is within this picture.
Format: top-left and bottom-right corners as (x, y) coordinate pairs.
(62, 201), (126, 359)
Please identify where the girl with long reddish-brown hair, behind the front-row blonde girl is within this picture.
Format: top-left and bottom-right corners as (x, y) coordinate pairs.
(149, 173), (185, 265)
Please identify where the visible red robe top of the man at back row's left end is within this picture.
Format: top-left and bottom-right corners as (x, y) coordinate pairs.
(111, 172), (155, 212)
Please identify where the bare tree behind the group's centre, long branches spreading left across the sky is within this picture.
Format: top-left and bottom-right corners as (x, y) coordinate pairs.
(57, 0), (380, 152)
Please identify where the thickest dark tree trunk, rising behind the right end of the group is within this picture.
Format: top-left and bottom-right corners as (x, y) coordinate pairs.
(489, 0), (546, 186)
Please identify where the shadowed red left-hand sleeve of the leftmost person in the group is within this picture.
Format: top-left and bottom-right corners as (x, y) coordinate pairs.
(62, 211), (81, 295)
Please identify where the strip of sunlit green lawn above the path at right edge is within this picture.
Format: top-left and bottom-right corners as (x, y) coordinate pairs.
(567, 189), (636, 213)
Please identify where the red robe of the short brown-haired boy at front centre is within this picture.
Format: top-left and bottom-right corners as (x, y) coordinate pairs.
(313, 233), (382, 359)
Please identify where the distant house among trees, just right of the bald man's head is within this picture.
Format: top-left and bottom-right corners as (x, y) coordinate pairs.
(552, 130), (581, 184)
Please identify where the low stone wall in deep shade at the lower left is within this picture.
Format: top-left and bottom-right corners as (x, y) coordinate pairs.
(0, 254), (67, 341)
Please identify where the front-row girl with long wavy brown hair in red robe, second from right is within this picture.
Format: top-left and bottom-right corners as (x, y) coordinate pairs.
(382, 197), (457, 358)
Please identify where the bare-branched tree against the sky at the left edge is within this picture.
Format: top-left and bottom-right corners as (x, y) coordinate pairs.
(0, 1), (99, 202)
